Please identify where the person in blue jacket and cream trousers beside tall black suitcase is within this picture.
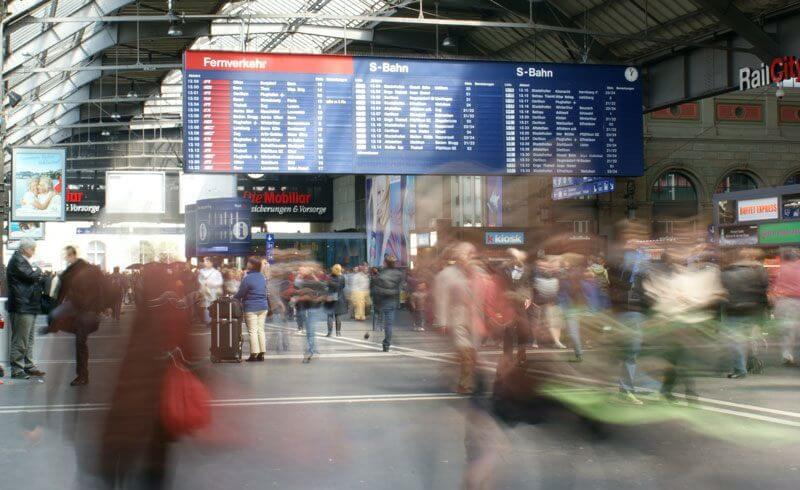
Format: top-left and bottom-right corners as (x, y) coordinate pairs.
(234, 257), (269, 362)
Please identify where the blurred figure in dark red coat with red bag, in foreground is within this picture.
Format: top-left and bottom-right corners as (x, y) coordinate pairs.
(100, 263), (210, 489)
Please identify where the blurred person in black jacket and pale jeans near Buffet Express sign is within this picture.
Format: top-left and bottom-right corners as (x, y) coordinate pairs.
(722, 249), (769, 379)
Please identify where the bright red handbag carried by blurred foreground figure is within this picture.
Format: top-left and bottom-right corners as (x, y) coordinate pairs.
(161, 348), (211, 437)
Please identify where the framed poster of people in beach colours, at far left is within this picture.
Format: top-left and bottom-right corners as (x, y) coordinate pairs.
(11, 148), (67, 221)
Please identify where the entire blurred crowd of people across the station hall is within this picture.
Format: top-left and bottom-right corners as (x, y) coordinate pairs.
(6, 224), (800, 488)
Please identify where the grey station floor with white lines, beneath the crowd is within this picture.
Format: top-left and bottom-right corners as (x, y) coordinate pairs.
(0, 310), (800, 490)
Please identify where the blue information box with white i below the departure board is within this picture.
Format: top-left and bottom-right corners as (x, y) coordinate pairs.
(195, 198), (252, 256)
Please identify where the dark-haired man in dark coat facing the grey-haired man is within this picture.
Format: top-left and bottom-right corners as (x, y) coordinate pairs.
(49, 246), (111, 386)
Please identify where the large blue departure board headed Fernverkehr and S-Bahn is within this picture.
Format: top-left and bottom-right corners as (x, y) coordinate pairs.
(183, 51), (644, 176)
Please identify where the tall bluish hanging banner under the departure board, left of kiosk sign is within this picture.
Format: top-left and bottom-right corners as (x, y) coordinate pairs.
(366, 175), (416, 266)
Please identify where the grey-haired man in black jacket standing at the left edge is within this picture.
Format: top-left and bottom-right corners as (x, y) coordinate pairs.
(6, 238), (45, 379)
